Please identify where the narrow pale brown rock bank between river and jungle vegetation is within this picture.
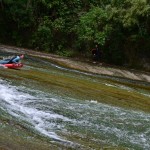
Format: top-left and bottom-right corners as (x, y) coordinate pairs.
(0, 45), (150, 82)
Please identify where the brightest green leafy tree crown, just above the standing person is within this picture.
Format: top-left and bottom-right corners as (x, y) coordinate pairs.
(78, 7), (108, 45)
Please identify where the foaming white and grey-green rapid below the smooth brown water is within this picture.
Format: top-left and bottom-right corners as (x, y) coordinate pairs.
(0, 80), (150, 150)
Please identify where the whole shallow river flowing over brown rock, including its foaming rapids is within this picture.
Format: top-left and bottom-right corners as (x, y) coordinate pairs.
(0, 50), (150, 150)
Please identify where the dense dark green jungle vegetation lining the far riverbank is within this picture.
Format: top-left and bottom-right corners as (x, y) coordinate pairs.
(0, 0), (150, 69)
